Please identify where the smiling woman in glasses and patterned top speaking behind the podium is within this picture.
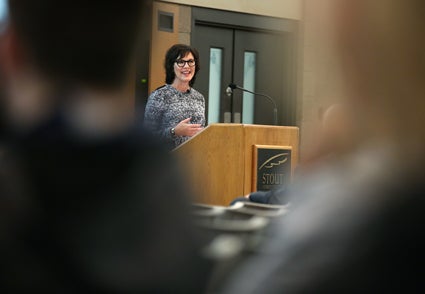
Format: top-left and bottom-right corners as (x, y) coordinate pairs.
(144, 44), (205, 148)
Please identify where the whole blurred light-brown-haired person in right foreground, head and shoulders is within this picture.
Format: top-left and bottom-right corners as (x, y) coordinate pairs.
(222, 0), (425, 293)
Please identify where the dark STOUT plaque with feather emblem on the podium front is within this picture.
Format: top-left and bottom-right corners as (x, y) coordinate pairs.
(252, 145), (292, 191)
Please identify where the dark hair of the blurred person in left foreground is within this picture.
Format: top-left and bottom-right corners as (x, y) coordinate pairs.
(9, 0), (143, 88)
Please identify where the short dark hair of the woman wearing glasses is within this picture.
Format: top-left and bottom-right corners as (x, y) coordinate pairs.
(164, 44), (201, 87)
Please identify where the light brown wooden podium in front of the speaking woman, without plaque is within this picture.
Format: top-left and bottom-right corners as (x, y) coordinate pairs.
(174, 124), (299, 206)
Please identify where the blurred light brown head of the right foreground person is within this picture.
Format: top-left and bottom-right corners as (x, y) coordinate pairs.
(330, 0), (425, 161)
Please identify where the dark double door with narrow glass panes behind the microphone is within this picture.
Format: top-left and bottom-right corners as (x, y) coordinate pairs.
(192, 9), (295, 125)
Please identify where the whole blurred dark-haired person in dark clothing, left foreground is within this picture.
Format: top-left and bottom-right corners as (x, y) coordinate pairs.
(0, 0), (210, 293)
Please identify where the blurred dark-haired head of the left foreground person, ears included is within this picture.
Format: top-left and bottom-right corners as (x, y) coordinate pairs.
(0, 0), (144, 134)
